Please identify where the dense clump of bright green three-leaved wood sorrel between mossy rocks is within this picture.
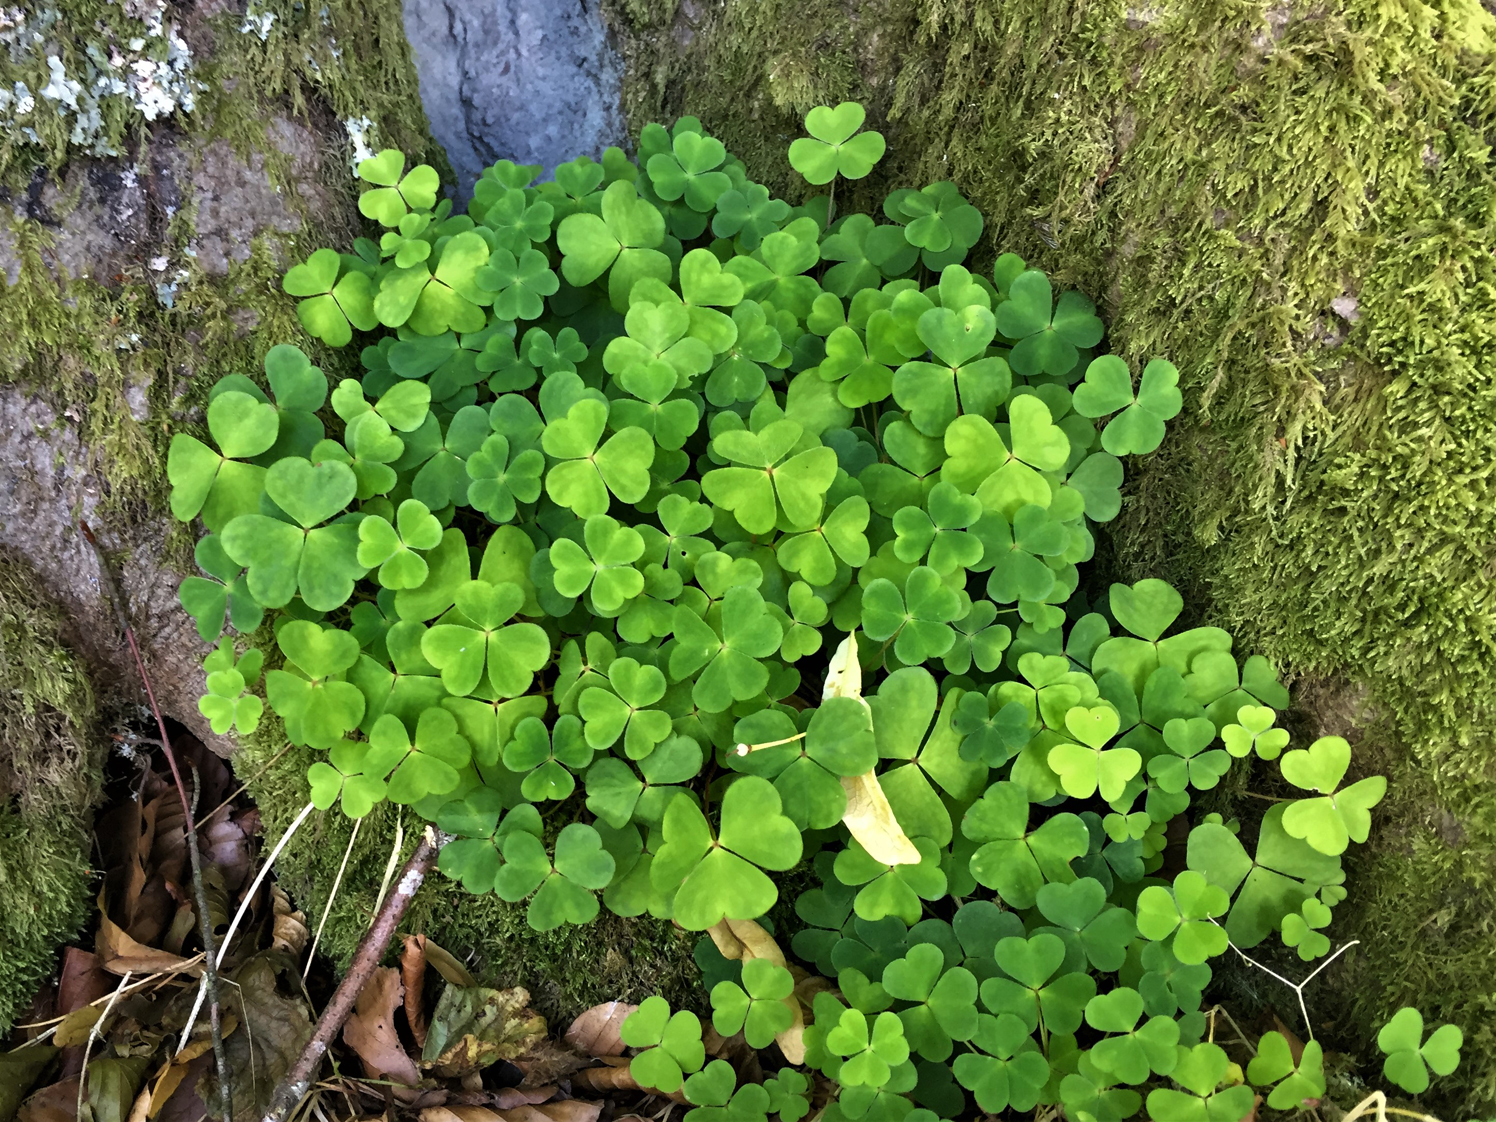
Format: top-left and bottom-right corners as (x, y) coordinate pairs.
(169, 103), (1459, 1122)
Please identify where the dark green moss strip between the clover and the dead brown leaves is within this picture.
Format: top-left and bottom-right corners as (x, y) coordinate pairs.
(236, 736), (705, 1026)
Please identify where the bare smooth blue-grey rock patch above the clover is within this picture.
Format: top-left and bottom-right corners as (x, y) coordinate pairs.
(404, 0), (625, 200)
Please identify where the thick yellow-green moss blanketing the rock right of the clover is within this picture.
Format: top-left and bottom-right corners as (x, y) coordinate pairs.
(613, 0), (1496, 1110)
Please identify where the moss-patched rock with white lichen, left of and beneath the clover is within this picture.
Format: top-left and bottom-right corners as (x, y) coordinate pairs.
(0, 0), (696, 1035)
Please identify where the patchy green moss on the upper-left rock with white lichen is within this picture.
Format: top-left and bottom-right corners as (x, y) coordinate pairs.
(0, 0), (446, 509)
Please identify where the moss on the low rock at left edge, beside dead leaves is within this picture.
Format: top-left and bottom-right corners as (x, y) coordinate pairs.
(0, 551), (103, 1034)
